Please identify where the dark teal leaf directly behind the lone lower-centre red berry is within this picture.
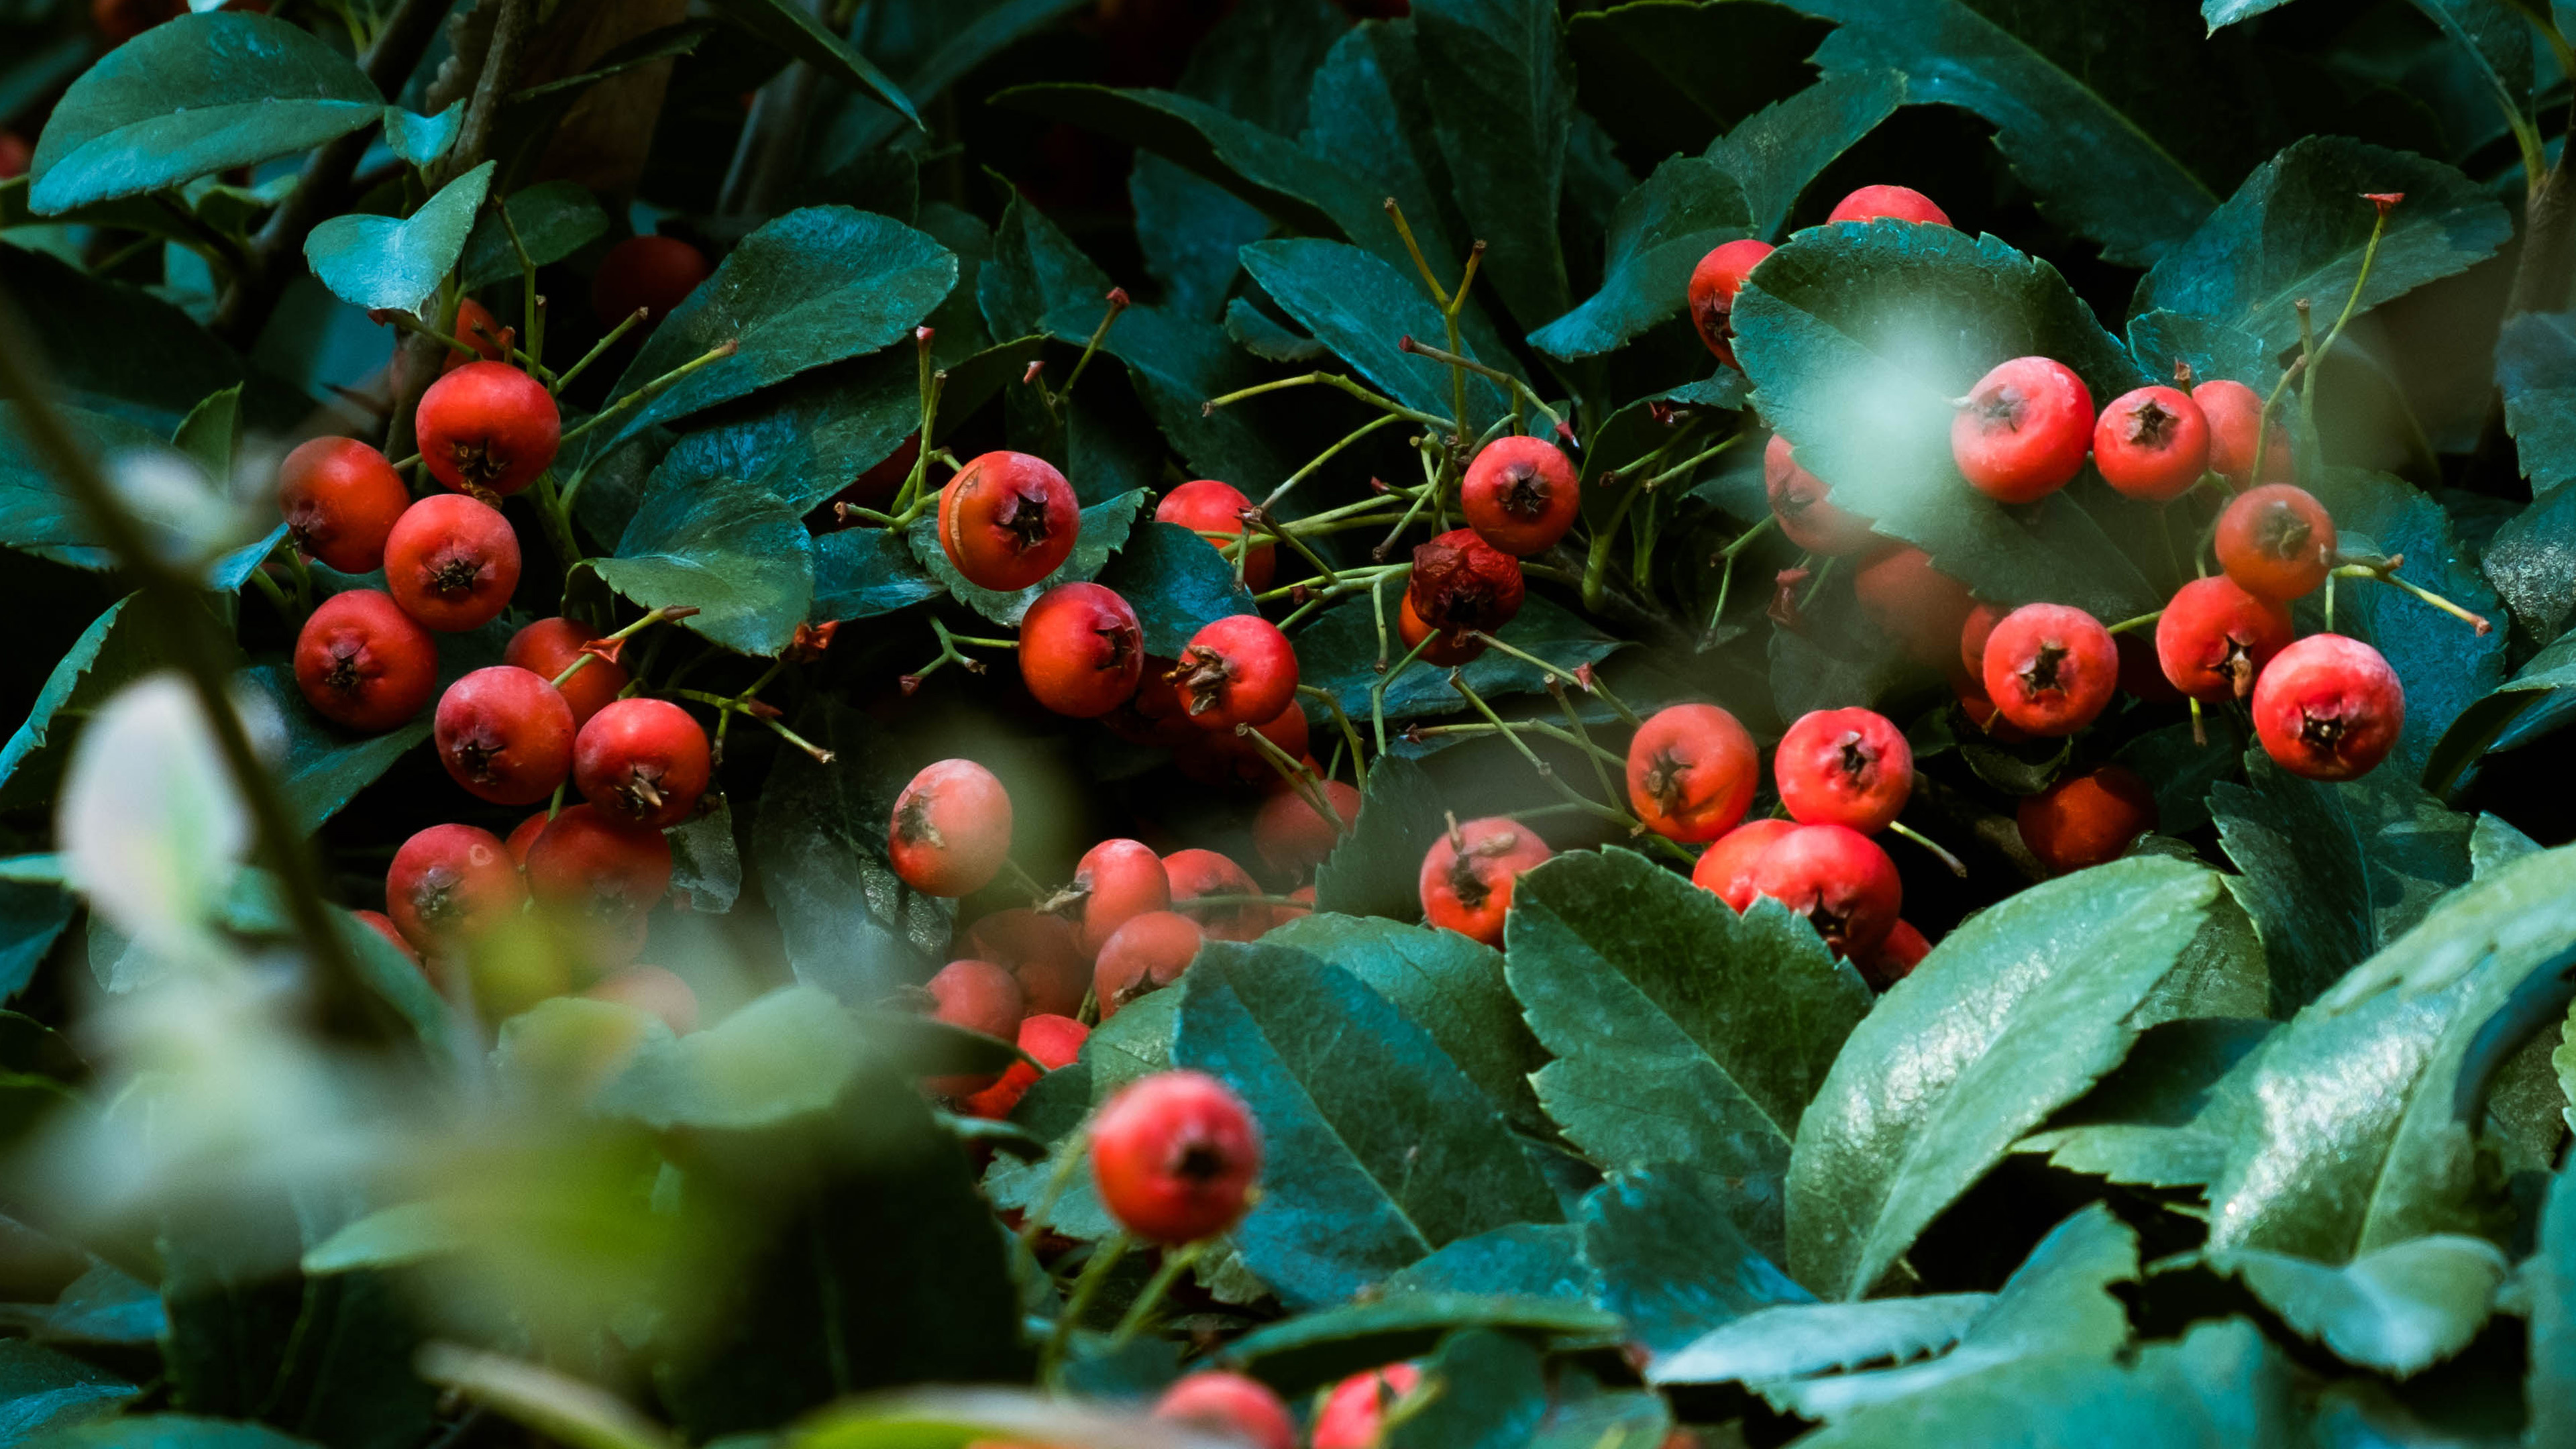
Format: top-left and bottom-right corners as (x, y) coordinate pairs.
(1172, 941), (1561, 1307)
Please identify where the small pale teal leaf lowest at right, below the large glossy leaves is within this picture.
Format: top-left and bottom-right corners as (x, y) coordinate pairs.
(2208, 1232), (2506, 1379)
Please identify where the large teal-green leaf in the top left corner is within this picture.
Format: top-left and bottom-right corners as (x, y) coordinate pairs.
(28, 13), (384, 217)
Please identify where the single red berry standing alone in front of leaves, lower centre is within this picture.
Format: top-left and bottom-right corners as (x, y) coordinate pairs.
(1092, 1073), (1263, 1248)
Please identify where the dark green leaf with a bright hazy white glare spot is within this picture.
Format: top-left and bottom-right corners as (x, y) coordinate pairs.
(1733, 223), (2161, 619)
